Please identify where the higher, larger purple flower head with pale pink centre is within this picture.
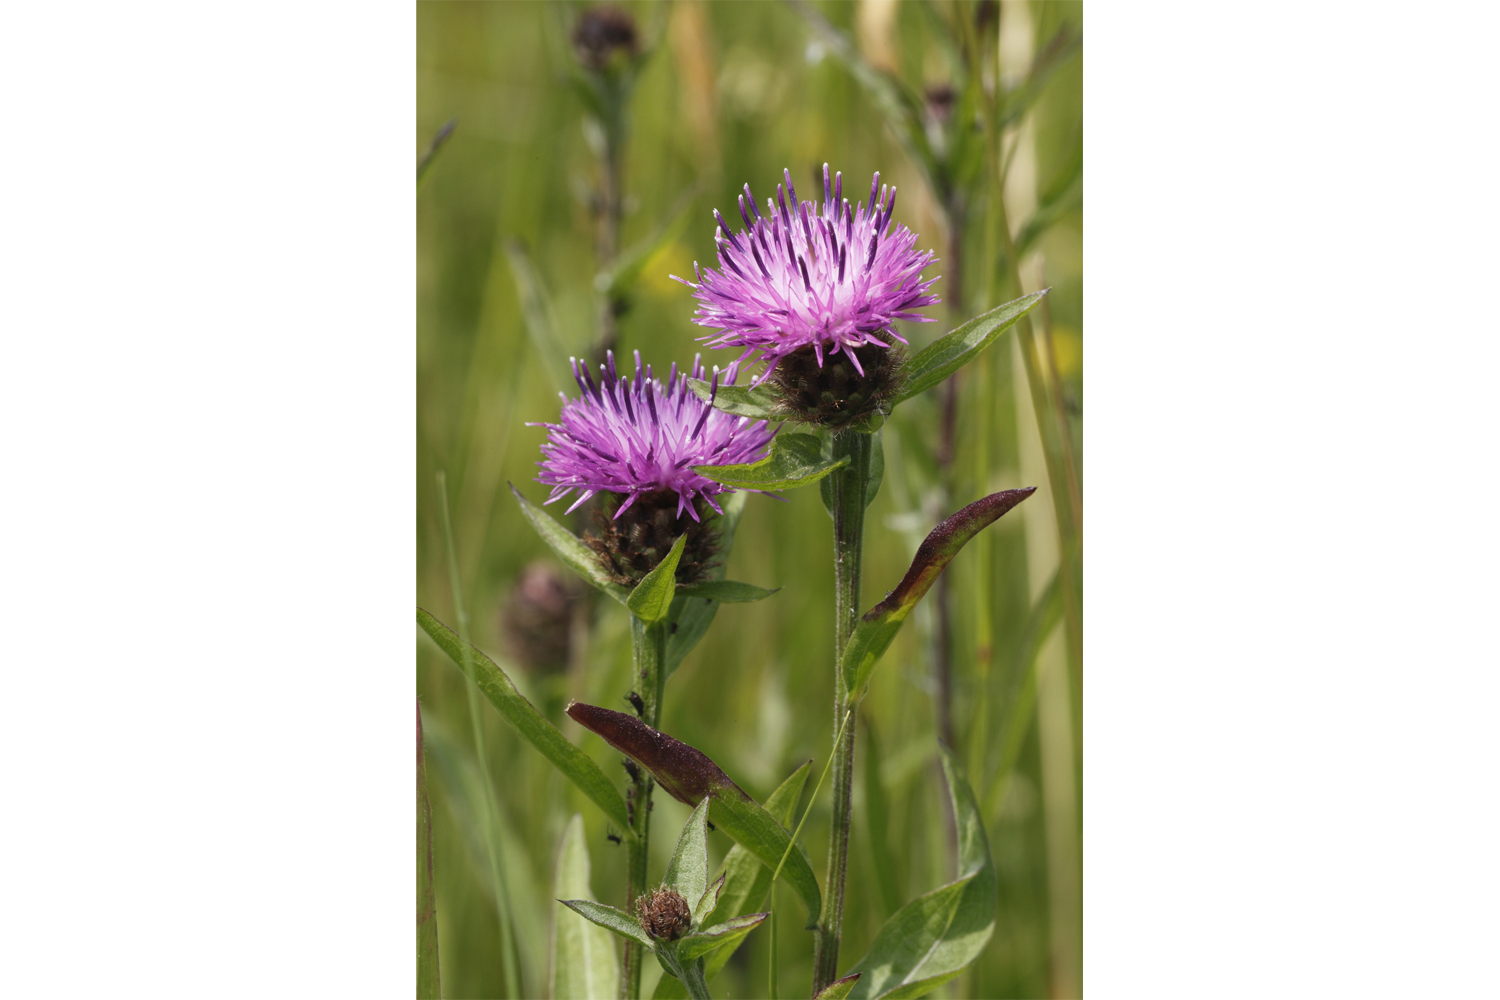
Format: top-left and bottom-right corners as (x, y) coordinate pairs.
(674, 163), (939, 382)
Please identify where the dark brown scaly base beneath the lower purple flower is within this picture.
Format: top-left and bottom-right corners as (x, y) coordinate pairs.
(584, 490), (719, 586)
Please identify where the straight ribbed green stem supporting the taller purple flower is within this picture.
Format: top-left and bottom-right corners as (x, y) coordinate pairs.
(813, 430), (870, 993)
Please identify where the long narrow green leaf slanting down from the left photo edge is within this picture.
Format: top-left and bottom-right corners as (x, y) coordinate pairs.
(417, 607), (636, 840)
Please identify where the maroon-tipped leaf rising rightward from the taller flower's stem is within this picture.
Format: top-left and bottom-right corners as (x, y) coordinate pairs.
(839, 486), (1037, 699)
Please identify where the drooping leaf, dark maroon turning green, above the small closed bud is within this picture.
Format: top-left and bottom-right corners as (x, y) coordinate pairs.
(567, 702), (822, 927)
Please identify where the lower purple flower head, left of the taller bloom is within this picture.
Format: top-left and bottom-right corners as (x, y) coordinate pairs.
(531, 351), (776, 520)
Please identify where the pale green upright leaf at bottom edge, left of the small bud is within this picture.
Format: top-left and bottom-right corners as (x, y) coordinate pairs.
(549, 813), (620, 1000)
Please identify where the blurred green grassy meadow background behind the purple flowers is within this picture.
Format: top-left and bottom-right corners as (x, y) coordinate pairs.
(416, 0), (1083, 1000)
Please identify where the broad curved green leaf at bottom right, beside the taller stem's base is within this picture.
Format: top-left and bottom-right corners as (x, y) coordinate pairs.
(848, 745), (998, 1000)
